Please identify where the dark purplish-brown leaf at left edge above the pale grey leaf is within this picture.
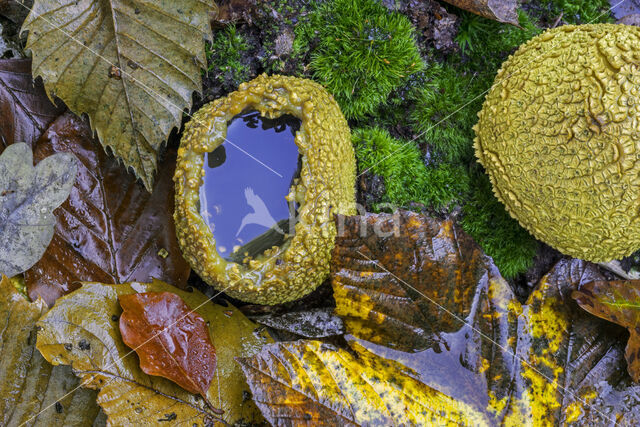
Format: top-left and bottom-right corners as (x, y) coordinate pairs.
(0, 59), (65, 153)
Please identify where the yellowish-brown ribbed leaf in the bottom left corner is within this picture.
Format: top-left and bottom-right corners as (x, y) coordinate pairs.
(0, 276), (99, 427)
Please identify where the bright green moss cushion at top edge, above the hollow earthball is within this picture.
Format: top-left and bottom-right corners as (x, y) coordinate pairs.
(294, 0), (423, 118)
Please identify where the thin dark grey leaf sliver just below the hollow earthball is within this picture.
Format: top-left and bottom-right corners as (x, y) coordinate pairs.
(255, 308), (344, 338)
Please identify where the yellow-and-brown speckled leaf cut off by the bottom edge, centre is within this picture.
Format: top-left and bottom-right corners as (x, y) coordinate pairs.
(238, 341), (489, 426)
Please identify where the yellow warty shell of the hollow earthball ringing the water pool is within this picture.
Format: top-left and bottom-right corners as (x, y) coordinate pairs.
(174, 75), (356, 304)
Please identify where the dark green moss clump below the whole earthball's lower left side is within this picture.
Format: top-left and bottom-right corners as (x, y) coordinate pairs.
(461, 166), (538, 278)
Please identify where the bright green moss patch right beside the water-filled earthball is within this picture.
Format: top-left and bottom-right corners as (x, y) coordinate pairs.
(352, 127), (469, 208)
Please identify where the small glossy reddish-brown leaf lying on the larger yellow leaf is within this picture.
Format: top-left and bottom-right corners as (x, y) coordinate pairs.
(118, 292), (216, 398)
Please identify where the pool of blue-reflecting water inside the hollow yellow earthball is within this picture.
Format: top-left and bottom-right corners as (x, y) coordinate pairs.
(200, 110), (300, 261)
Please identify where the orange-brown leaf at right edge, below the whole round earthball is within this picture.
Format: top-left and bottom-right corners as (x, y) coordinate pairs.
(572, 280), (640, 382)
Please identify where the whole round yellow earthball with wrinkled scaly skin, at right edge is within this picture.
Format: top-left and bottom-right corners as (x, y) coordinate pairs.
(474, 24), (640, 262)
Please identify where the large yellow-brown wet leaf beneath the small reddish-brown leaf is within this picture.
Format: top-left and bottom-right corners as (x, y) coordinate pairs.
(37, 281), (266, 426)
